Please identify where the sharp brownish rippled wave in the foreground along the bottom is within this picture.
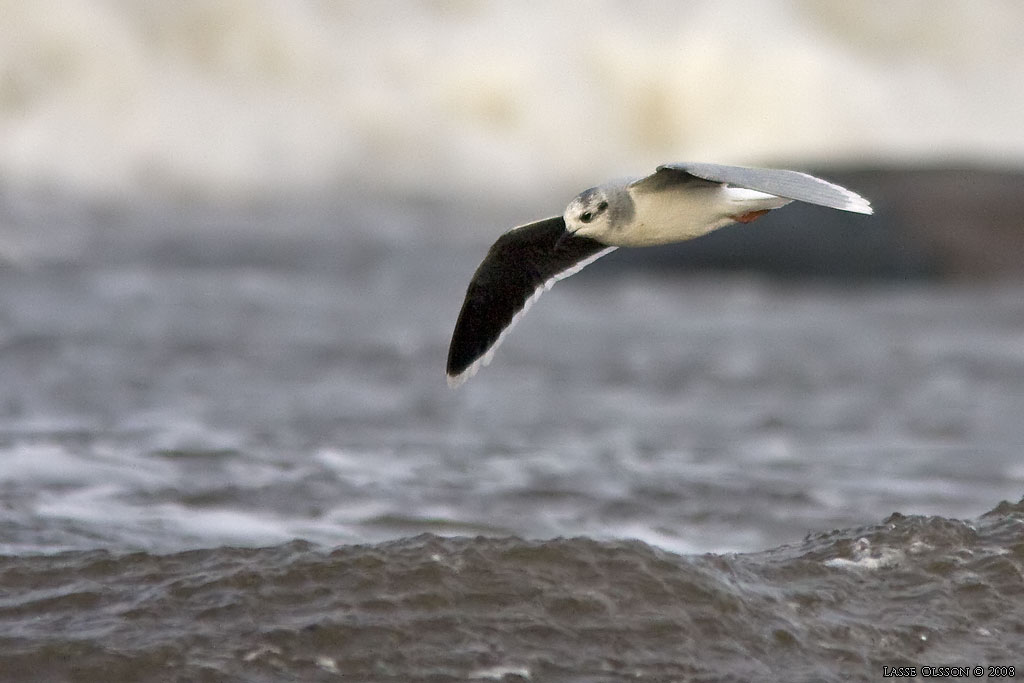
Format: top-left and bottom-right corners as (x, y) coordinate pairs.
(0, 504), (1024, 681)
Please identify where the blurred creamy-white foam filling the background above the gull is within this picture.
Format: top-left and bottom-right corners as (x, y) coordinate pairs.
(0, 0), (1024, 202)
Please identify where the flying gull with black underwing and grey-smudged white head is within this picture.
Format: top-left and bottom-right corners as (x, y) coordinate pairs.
(447, 158), (871, 387)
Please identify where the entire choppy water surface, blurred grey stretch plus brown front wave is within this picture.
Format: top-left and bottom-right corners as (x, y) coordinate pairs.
(0, 197), (1024, 681)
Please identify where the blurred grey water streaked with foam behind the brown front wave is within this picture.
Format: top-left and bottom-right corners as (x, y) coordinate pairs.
(6, 242), (1024, 551)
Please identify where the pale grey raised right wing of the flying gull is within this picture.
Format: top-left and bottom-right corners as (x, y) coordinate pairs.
(632, 163), (872, 213)
